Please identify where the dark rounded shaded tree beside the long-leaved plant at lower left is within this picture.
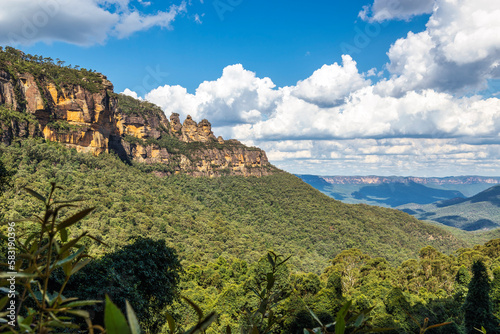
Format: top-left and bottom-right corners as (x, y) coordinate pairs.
(68, 238), (182, 332)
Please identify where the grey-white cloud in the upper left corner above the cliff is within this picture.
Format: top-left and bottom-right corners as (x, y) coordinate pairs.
(0, 0), (186, 45)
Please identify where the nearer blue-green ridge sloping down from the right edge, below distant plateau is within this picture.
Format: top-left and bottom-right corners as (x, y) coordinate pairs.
(399, 186), (500, 231)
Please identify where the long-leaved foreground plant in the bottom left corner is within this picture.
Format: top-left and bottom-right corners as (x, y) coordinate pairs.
(0, 183), (99, 333)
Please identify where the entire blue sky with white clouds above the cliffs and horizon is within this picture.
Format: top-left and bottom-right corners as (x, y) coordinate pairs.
(0, 0), (500, 176)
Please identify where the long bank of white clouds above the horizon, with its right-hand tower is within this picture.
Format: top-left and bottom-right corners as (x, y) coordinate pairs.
(121, 0), (500, 176)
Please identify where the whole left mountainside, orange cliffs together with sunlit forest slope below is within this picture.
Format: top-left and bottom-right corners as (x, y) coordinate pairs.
(0, 49), (492, 271)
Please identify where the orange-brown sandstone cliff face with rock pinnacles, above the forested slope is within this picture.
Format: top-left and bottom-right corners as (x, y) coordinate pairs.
(0, 52), (274, 176)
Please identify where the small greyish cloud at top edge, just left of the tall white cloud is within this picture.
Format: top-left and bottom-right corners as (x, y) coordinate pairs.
(359, 0), (435, 22)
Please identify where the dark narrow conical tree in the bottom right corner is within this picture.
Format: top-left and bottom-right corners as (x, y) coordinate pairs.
(462, 261), (500, 334)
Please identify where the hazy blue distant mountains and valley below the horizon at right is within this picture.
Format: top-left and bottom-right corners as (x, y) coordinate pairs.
(297, 175), (500, 231)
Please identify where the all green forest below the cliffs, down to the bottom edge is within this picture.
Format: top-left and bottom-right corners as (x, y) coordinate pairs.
(0, 139), (500, 333)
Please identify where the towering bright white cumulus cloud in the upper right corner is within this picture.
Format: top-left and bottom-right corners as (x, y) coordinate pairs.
(378, 0), (500, 96)
